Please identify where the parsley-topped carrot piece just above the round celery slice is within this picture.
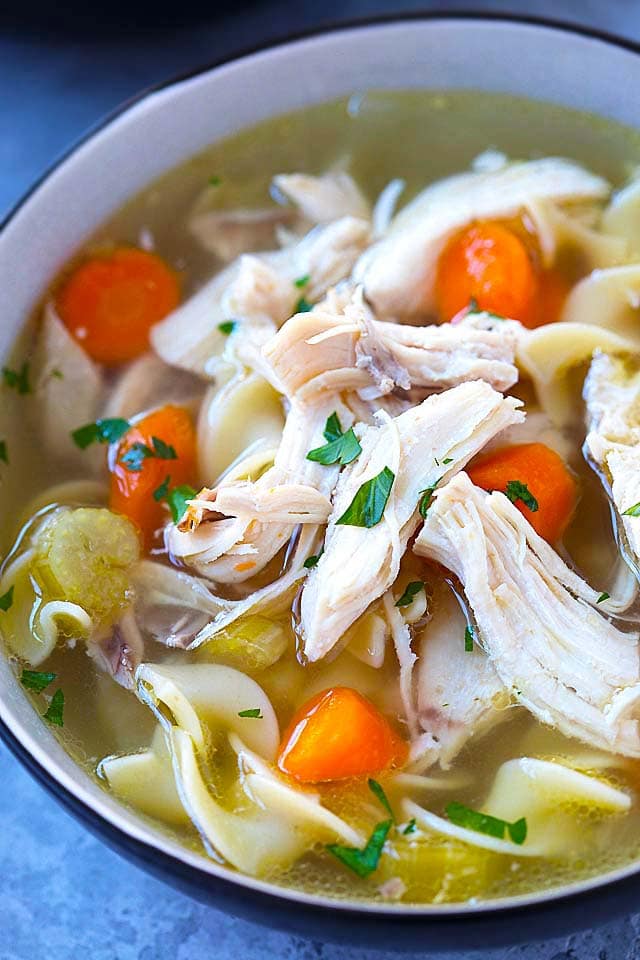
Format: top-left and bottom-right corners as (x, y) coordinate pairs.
(109, 405), (196, 548)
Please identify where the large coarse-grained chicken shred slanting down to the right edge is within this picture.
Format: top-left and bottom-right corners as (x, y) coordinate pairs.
(414, 473), (640, 757)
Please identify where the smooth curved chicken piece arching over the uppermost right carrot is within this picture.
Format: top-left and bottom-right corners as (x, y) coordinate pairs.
(354, 157), (610, 322)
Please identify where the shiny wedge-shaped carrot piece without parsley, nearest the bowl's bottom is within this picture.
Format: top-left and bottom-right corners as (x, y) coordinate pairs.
(278, 687), (407, 783)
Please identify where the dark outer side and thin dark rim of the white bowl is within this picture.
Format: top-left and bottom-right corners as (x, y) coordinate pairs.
(0, 9), (640, 936)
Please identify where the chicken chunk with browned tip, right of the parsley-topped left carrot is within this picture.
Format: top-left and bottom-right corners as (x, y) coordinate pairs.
(166, 397), (344, 583)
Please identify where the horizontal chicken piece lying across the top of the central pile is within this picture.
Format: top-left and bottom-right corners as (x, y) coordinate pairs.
(262, 288), (522, 397)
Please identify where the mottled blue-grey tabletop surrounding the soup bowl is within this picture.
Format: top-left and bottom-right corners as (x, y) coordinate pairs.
(0, 0), (640, 960)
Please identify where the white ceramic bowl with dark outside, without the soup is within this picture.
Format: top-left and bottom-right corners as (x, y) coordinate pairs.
(0, 16), (640, 951)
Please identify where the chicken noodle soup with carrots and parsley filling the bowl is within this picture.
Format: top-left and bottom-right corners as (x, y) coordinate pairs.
(6, 92), (640, 903)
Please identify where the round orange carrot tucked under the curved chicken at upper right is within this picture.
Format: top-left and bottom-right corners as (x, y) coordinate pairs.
(436, 221), (537, 326)
